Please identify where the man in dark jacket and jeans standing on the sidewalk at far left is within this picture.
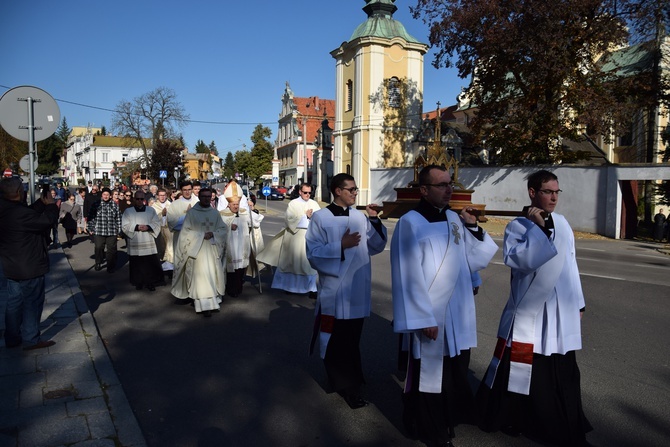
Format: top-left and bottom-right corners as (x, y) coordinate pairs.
(0, 178), (58, 350)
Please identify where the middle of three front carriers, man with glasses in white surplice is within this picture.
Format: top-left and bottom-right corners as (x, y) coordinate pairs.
(391, 165), (498, 446)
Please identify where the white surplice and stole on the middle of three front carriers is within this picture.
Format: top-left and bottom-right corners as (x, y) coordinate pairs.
(391, 210), (498, 393)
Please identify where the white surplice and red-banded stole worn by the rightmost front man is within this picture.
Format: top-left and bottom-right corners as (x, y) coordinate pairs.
(485, 213), (585, 395)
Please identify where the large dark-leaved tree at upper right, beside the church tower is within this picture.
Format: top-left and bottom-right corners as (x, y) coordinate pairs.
(411, 0), (635, 163)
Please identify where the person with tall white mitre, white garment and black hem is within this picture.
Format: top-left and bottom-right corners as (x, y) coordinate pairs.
(220, 181), (264, 297)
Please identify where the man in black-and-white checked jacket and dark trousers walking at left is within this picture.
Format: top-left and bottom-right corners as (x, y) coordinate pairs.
(88, 188), (121, 273)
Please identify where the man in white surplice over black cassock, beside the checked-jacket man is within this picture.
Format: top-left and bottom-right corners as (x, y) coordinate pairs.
(121, 190), (164, 292)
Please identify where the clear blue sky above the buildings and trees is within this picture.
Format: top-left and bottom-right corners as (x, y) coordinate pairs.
(0, 0), (467, 155)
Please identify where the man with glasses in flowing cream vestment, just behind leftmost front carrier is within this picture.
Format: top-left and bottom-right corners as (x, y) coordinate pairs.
(258, 183), (321, 299)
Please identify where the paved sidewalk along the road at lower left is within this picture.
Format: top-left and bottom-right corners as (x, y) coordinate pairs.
(0, 248), (146, 447)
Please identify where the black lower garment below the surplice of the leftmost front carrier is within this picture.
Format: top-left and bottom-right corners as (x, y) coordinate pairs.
(323, 318), (365, 394)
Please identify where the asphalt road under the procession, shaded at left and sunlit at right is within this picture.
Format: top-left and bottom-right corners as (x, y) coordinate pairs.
(61, 202), (670, 447)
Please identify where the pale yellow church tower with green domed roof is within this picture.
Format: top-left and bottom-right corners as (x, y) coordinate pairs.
(330, 0), (428, 204)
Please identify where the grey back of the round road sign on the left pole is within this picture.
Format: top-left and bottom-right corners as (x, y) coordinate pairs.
(0, 85), (60, 141)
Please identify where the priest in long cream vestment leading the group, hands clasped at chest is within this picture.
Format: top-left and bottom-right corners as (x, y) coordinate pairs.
(172, 188), (227, 317)
